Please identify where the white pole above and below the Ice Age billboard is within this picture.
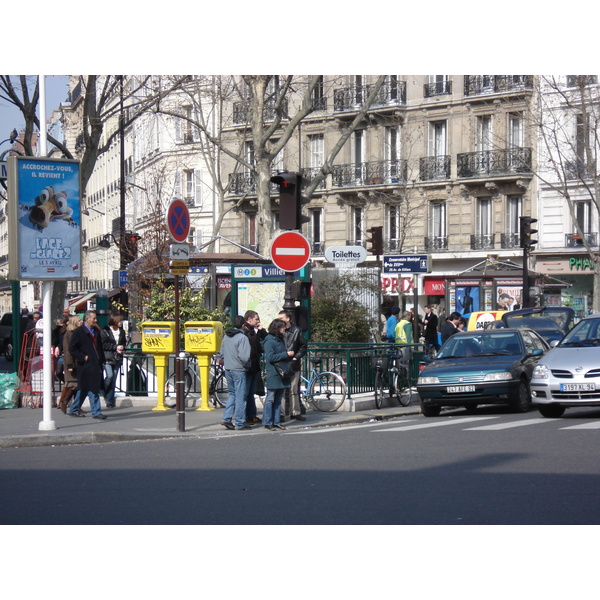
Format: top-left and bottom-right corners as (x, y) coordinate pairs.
(39, 75), (56, 431)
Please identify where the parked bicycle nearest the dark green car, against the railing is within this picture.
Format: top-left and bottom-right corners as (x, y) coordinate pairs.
(371, 346), (413, 408)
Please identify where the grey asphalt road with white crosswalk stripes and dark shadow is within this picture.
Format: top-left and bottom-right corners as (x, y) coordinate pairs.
(0, 408), (600, 525)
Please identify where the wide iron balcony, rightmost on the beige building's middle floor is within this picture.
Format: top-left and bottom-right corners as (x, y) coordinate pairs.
(456, 148), (531, 177)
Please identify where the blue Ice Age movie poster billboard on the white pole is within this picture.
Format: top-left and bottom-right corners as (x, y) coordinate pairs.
(8, 157), (81, 280)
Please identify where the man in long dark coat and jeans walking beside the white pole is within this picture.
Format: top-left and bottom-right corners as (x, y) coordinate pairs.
(67, 310), (106, 419)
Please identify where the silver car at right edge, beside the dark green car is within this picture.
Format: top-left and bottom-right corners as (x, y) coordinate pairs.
(530, 314), (600, 417)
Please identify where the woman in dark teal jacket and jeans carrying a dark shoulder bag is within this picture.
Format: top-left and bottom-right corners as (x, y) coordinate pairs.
(263, 319), (294, 431)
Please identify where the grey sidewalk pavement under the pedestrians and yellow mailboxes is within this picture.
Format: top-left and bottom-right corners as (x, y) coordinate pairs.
(0, 396), (421, 448)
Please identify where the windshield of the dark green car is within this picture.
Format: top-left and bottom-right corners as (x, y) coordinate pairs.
(437, 329), (522, 358)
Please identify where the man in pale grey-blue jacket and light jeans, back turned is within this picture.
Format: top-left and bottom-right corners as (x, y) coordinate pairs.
(221, 315), (252, 430)
